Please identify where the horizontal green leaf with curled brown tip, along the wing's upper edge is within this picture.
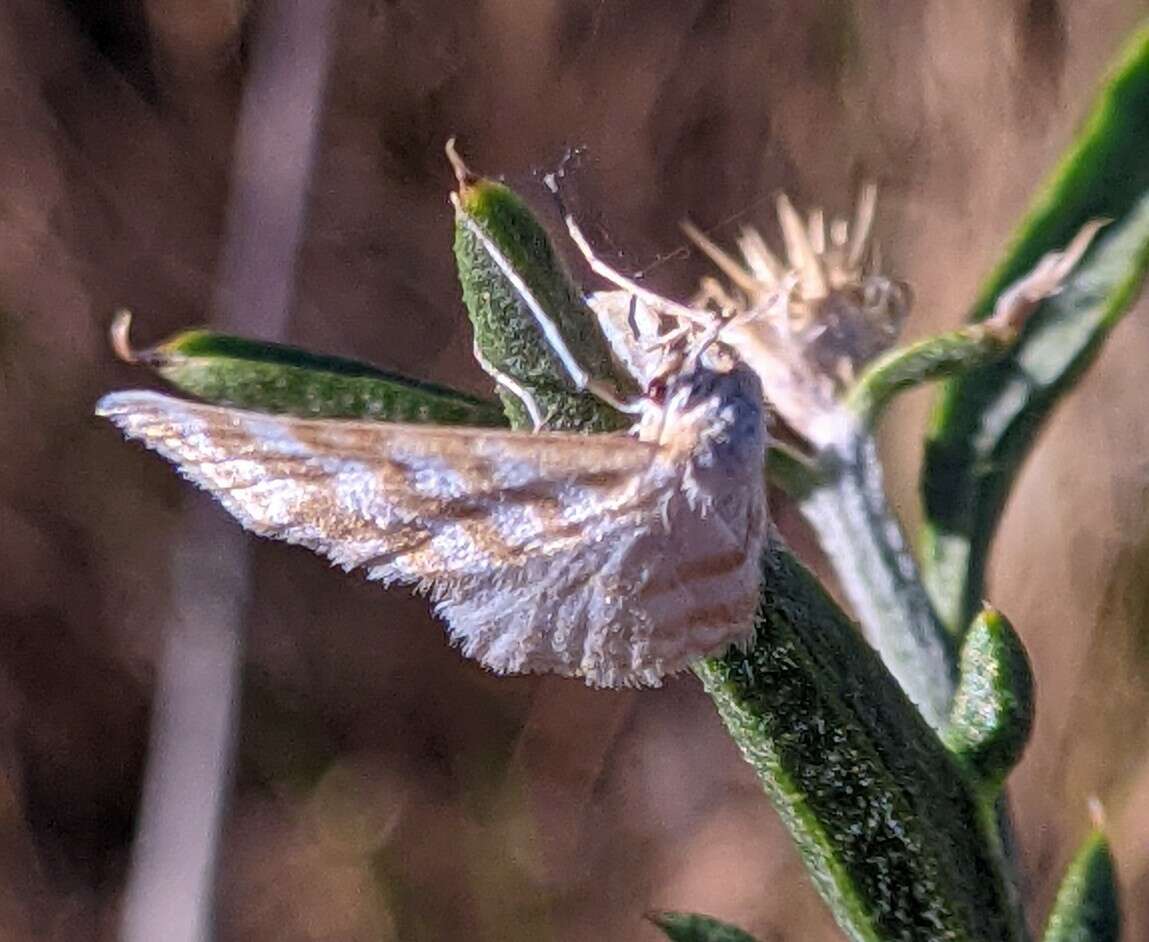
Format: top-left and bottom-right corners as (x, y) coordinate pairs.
(113, 315), (507, 426)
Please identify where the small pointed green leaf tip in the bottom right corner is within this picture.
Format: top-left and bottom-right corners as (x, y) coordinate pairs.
(1043, 829), (1121, 942)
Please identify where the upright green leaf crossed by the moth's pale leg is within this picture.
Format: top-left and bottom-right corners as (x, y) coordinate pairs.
(445, 149), (634, 432)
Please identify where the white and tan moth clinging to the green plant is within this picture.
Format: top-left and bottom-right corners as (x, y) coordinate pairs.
(97, 356), (766, 687)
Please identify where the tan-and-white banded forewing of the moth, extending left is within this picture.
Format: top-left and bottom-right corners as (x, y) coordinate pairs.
(97, 392), (658, 581)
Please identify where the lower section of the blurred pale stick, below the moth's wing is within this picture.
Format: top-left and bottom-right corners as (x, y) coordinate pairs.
(121, 514), (247, 942)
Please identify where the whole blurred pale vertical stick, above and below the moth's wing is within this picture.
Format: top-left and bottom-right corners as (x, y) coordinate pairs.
(121, 0), (334, 942)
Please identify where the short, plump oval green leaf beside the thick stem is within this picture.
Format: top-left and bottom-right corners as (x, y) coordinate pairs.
(944, 605), (1034, 792)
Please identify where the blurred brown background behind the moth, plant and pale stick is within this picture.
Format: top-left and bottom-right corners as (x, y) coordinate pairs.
(0, 0), (1149, 942)
